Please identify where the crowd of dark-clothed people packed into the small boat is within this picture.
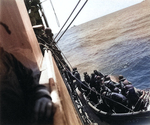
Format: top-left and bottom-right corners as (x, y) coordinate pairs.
(71, 68), (144, 112)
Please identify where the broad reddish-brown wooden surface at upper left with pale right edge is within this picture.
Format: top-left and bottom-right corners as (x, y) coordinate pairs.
(0, 0), (43, 71)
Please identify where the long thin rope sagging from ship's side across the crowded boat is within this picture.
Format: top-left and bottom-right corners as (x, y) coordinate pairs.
(51, 51), (133, 112)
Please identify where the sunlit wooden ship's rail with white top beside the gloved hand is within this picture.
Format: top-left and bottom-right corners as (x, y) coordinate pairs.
(40, 51), (82, 125)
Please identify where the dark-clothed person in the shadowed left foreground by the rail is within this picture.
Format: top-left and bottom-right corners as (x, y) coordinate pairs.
(0, 47), (52, 125)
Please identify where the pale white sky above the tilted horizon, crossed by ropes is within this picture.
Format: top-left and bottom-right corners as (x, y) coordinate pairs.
(41, 0), (143, 33)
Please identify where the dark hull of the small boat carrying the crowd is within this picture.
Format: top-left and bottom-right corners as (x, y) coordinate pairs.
(82, 75), (150, 121)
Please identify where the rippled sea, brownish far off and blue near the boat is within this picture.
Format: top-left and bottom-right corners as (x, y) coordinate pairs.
(58, 1), (150, 125)
